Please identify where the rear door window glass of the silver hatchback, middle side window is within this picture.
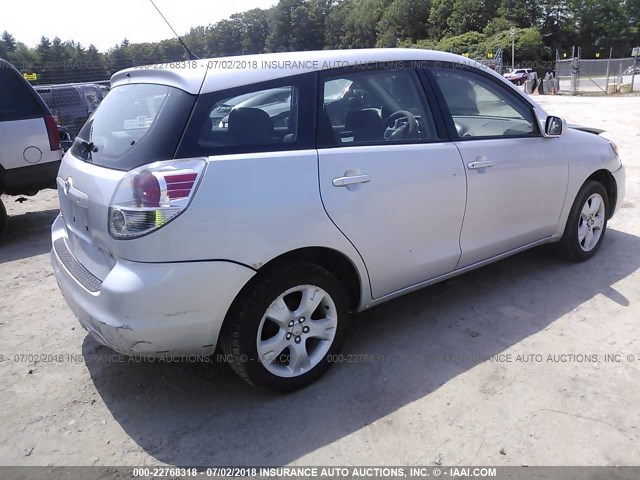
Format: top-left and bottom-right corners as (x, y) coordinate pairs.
(318, 69), (438, 147)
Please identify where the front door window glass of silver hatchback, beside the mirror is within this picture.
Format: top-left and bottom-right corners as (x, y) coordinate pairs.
(430, 67), (538, 138)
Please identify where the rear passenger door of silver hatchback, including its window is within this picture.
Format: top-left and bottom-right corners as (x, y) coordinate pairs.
(318, 68), (466, 298)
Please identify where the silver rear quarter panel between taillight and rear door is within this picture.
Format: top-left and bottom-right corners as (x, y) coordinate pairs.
(115, 150), (371, 303)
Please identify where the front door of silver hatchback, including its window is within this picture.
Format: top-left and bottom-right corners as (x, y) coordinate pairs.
(429, 66), (569, 268)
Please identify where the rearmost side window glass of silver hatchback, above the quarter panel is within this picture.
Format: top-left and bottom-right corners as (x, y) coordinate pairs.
(178, 75), (313, 157)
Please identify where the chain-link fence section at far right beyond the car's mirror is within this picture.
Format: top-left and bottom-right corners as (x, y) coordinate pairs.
(556, 56), (640, 95)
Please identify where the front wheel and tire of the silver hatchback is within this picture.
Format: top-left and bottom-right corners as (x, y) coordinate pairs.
(558, 180), (609, 262)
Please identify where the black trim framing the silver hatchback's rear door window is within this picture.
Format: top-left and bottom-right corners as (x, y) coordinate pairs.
(315, 59), (451, 150)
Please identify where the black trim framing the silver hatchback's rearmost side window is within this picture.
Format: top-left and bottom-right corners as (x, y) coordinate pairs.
(174, 72), (317, 158)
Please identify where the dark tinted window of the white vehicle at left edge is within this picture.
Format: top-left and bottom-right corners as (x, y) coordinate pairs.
(0, 63), (44, 122)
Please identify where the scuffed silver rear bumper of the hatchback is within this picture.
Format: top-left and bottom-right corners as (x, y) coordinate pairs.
(51, 217), (255, 356)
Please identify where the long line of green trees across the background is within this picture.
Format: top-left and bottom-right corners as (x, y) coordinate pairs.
(0, 0), (640, 83)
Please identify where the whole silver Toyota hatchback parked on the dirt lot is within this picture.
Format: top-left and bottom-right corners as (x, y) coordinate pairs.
(52, 49), (625, 391)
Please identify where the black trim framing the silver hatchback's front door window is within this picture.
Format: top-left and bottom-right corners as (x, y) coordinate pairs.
(422, 60), (543, 142)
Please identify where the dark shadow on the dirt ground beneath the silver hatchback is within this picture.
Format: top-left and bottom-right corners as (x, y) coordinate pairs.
(83, 230), (640, 465)
